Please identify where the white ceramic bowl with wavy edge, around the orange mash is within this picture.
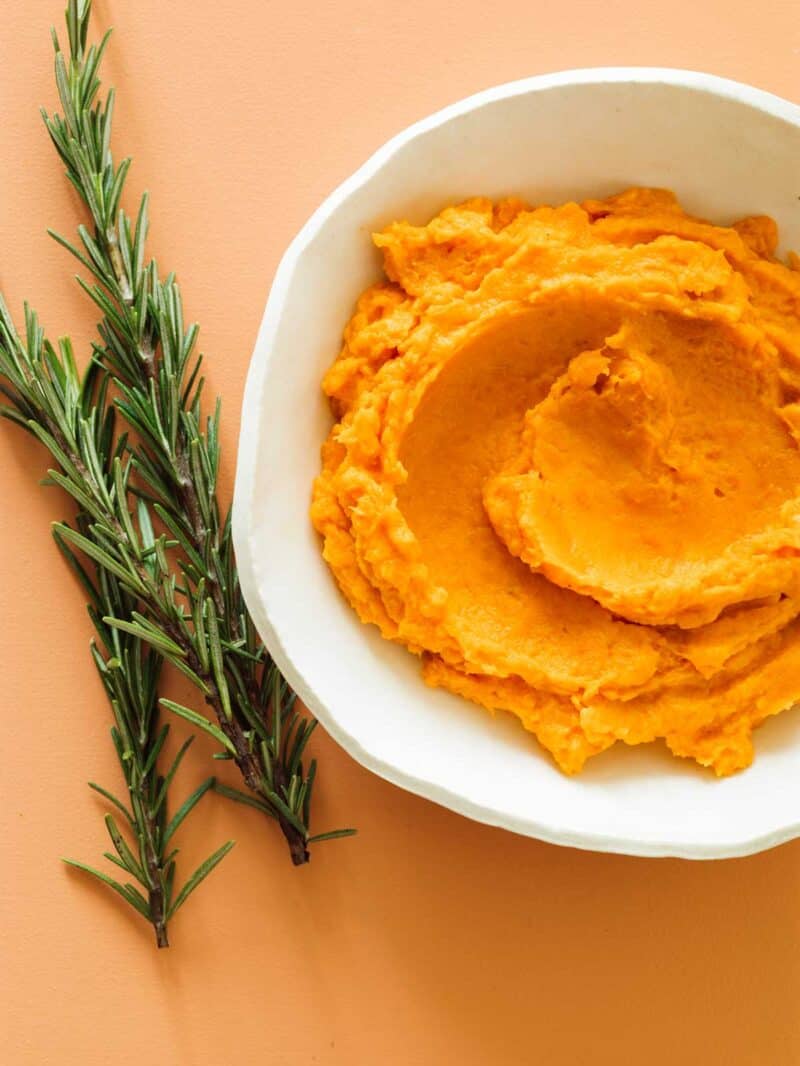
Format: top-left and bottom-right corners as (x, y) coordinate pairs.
(234, 68), (800, 858)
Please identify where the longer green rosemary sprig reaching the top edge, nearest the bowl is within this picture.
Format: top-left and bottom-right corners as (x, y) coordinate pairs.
(44, 0), (353, 865)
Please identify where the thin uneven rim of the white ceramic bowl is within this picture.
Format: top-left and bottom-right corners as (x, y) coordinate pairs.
(233, 66), (800, 859)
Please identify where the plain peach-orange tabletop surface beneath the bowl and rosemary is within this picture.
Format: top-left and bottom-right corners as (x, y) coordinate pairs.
(0, 0), (800, 1066)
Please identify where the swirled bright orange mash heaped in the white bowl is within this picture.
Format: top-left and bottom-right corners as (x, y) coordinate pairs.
(311, 189), (800, 774)
